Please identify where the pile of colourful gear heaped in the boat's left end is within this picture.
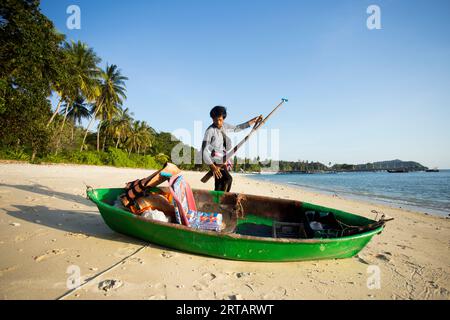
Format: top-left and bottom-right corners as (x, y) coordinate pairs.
(114, 163), (225, 231)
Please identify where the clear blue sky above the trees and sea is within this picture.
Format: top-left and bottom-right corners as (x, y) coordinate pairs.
(41, 0), (450, 168)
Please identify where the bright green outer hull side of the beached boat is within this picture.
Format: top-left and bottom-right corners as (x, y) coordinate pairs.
(87, 189), (383, 262)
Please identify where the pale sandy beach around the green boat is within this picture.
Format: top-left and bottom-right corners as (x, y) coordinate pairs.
(0, 162), (450, 300)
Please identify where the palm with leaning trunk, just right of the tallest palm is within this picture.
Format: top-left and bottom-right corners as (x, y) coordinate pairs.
(80, 64), (128, 151)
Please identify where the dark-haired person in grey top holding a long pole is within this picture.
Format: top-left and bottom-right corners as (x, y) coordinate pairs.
(202, 106), (262, 192)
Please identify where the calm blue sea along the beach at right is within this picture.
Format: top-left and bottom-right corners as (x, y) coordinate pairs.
(251, 170), (450, 216)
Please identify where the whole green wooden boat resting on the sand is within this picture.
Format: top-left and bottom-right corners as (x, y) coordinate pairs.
(87, 187), (385, 262)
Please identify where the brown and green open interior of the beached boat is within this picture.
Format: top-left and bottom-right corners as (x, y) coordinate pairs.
(118, 187), (384, 239)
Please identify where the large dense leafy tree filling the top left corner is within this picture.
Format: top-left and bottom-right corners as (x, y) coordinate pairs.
(0, 0), (64, 158)
